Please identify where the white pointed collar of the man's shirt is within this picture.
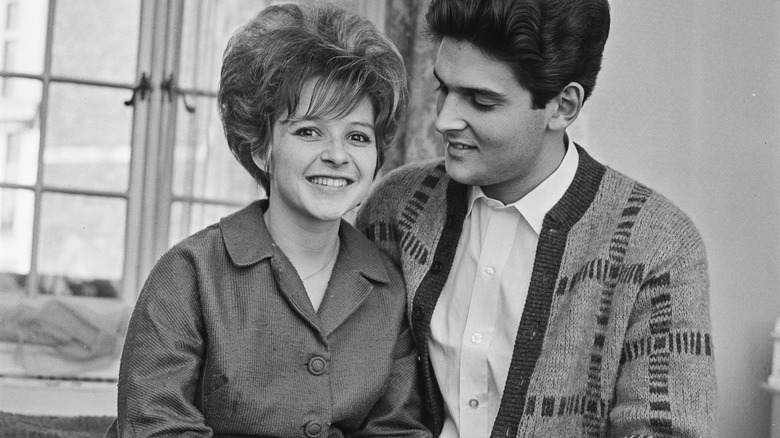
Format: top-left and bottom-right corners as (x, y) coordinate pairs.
(466, 135), (579, 234)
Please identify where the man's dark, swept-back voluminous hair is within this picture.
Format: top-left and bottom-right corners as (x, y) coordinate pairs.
(425, 0), (610, 109)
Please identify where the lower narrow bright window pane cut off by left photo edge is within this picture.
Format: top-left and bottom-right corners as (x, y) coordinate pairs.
(0, 189), (35, 294)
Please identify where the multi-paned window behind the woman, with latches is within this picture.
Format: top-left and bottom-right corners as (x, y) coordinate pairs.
(0, 0), (384, 384)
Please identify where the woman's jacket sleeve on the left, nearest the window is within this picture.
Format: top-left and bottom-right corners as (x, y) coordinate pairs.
(118, 248), (212, 437)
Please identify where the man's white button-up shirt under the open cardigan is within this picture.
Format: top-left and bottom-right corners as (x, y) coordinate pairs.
(428, 138), (579, 438)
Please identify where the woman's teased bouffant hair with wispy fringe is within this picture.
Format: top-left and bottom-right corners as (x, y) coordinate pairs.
(217, 2), (409, 193)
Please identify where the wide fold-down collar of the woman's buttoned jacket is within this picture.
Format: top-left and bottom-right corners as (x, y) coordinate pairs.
(219, 199), (390, 283)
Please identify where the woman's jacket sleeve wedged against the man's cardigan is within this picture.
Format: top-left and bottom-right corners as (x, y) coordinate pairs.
(348, 318), (431, 438)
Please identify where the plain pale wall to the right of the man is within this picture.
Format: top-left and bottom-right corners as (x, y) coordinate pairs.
(572, 0), (780, 438)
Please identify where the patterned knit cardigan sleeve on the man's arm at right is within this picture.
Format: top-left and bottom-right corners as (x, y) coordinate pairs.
(609, 233), (717, 438)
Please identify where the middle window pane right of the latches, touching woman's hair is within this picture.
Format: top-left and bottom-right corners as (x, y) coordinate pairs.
(173, 97), (263, 203)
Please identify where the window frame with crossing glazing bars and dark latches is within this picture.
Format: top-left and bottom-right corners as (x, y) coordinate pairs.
(0, 0), (386, 334)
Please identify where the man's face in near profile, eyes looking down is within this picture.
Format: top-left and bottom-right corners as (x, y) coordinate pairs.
(434, 38), (565, 203)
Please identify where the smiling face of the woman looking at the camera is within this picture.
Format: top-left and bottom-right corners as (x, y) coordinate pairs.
(255, 80), (377, 223)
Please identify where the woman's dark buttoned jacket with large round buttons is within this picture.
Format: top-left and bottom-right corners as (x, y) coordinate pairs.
(118, 202), (429, 437)
